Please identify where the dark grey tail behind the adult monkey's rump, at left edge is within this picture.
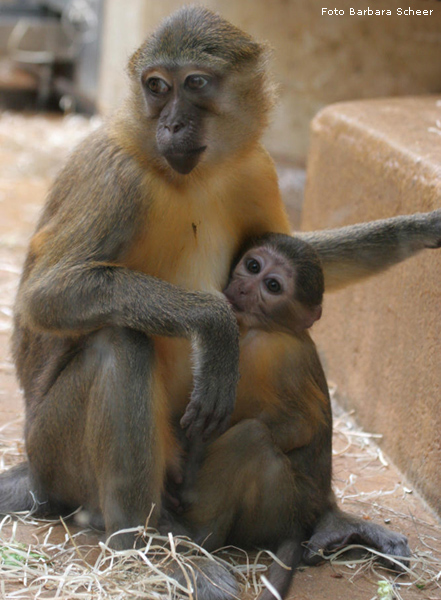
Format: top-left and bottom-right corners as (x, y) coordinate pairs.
(0, 462), (34, 514)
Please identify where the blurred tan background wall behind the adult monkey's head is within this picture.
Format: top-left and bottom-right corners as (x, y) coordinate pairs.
(99, 0), (441, 164)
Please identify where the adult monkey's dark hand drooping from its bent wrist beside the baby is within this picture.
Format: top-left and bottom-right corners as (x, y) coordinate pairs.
(181, 300), (239, 440)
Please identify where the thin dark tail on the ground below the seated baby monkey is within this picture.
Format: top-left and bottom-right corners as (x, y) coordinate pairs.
(258, 539), (303, 600)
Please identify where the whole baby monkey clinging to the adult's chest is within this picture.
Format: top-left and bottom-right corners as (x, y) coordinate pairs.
(165, 233), (332, 599)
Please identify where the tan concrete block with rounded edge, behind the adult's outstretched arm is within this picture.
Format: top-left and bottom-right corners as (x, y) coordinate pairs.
(303, 96), (441, 515)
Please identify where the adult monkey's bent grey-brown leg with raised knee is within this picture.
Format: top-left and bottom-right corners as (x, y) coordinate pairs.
(26, 327), (167, 548)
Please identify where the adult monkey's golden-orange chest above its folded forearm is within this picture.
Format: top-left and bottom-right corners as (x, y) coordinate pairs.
(123, 157), (289, 292)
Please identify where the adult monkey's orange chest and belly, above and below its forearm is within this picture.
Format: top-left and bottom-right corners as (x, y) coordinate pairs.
(122, 166), (287, 410)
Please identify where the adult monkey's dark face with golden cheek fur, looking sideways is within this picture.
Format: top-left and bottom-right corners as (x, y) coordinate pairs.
(141, 65), (265, 175)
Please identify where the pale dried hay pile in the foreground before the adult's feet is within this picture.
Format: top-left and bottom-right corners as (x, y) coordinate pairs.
(0, 510), (276, 600)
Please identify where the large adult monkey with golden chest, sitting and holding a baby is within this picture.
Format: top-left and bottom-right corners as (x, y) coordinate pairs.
(0, 7), (441, 600)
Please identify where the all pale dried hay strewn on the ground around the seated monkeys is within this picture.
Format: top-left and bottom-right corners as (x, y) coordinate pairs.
(0, 390), (441, 600)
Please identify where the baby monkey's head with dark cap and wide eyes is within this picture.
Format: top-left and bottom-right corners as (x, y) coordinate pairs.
(224, 233), (324, 335)
